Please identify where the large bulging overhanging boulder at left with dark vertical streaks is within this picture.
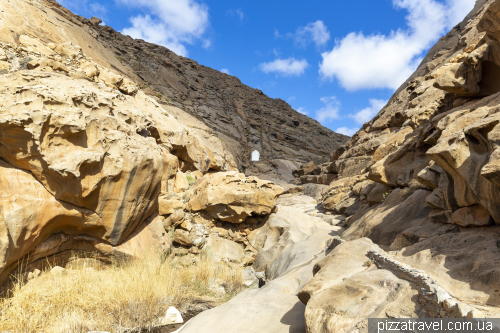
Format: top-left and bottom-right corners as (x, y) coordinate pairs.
(0, 71), (162, 245)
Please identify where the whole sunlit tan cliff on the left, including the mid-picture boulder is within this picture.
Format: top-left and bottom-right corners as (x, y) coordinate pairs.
(0, 0), (288, 282)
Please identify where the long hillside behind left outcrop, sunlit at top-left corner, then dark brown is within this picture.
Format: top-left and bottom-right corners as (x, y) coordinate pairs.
(2, 0), (348, 171)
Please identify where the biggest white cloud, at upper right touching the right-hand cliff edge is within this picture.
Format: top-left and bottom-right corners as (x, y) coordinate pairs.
(319, 0), (475, 90)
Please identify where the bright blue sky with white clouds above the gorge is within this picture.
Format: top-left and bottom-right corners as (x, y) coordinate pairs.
(59, 0), (475, 135)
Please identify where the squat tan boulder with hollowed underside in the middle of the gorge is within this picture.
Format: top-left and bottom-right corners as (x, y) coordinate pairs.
(187, 171), (283, 223)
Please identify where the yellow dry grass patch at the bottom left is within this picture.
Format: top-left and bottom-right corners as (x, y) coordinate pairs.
(0, 255), (242, 333)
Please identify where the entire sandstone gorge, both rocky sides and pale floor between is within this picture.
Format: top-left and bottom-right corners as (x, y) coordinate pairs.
(6, 0), (500, 333)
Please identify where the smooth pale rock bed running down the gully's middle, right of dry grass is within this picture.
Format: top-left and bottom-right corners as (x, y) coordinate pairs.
(179, 195), (342, 333)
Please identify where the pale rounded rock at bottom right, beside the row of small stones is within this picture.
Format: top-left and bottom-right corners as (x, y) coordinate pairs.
(299, 238), (426, 333)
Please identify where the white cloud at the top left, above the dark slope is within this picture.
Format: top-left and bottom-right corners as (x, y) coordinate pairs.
(117, 0), (210, 56)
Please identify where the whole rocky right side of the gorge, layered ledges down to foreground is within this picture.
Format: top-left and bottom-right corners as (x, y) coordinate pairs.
(286, 0), (500, 326)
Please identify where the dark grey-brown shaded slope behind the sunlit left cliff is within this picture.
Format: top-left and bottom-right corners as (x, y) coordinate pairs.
(88, 18), (347, 167)
